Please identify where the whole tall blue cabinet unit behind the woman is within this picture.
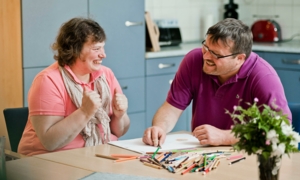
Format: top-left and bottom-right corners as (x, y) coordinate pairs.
(22, 0), (146, 139)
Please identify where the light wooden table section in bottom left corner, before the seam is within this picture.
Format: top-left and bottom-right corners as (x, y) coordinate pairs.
(6, 157), (93, 180)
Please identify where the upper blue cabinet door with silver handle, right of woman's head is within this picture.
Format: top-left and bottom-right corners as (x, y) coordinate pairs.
(89, 0), (145, 78)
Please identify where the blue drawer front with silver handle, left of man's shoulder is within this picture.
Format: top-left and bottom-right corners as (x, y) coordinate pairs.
(146, 56), (183, 75)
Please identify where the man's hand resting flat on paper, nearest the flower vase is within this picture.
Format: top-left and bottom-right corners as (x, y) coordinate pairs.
(193, 124), (237, 146)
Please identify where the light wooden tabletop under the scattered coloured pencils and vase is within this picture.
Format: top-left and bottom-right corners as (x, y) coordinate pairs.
(34, 144), (300, 180)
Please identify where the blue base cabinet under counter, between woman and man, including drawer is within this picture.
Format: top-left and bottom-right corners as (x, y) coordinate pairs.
(146, 56), (191, 131)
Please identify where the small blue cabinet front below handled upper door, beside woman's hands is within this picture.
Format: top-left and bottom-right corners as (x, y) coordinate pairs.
(118, 77), (145, 113)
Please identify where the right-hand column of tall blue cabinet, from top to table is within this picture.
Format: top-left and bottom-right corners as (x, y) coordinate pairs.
(89, 0), (146, 139)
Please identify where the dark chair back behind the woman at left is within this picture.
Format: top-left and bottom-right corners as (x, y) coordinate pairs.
(3, 107), (28, 152)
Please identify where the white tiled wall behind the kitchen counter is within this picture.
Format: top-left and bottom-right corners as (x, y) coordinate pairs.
(145, 0), (300, 42)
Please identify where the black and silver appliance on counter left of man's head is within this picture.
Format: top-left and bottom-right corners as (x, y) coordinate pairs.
(154, 19), (182, 47)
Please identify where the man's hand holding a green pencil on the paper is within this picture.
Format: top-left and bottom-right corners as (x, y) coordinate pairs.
(143, 126), (166, 146)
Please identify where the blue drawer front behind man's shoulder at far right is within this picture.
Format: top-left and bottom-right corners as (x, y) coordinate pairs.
(264, 52), (300, 70)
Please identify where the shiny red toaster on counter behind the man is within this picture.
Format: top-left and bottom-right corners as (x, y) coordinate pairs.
(251, 19), (282, 42)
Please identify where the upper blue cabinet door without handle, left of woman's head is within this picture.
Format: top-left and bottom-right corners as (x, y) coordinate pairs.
(22, 0), (88, 67)
